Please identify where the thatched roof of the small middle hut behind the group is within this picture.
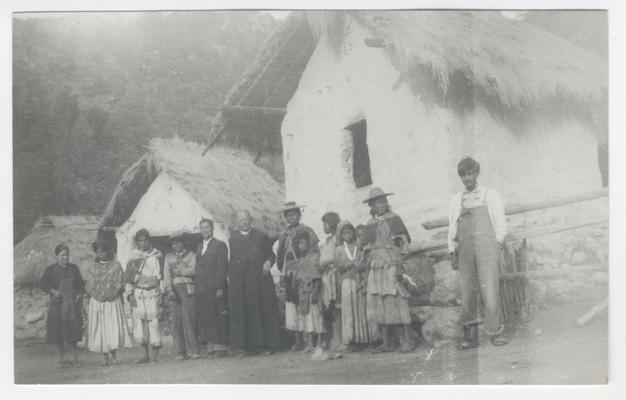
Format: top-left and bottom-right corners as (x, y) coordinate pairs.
(100, 138), (284, 235)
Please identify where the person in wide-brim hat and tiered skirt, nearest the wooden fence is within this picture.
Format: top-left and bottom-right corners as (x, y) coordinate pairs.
(364, 188), (413, 353)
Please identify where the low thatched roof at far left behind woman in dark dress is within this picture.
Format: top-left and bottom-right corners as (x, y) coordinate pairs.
(13, 216), (99, 286)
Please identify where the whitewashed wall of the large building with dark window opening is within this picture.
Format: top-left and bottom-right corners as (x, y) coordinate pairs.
(282, 21), (600, 244)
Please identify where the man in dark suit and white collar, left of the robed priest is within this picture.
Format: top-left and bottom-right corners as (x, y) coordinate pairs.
(195, 218), (228, 357)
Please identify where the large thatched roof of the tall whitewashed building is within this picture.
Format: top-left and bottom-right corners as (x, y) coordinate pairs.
(209, 11), (608, 152)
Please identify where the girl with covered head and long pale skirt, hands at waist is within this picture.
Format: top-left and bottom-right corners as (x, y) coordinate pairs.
(334, 221), (377, 351)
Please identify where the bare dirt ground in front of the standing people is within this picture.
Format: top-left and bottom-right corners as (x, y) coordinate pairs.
(15, 287), (608, 384)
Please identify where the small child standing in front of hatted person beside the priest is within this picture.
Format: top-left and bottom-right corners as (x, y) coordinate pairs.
(294, 231), (324, 353)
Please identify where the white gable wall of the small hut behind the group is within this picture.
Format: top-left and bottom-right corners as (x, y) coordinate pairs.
(116, 173), (229, 268)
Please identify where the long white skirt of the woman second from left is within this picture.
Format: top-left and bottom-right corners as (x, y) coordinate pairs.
(87, 297), (132, 353)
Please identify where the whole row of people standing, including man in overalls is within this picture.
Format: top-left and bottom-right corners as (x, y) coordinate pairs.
(41, 158), (506, 366)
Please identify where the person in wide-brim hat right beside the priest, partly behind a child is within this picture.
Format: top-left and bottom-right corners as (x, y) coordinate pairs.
(276, 201), (319, 351)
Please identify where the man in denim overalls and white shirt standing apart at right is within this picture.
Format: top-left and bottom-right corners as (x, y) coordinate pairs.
(448, 157), (507, 350)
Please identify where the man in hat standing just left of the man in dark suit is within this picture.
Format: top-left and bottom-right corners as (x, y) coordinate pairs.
(163, 231), (199, 360)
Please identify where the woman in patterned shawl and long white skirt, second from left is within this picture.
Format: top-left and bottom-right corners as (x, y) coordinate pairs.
(85, 242), (131, 366)
